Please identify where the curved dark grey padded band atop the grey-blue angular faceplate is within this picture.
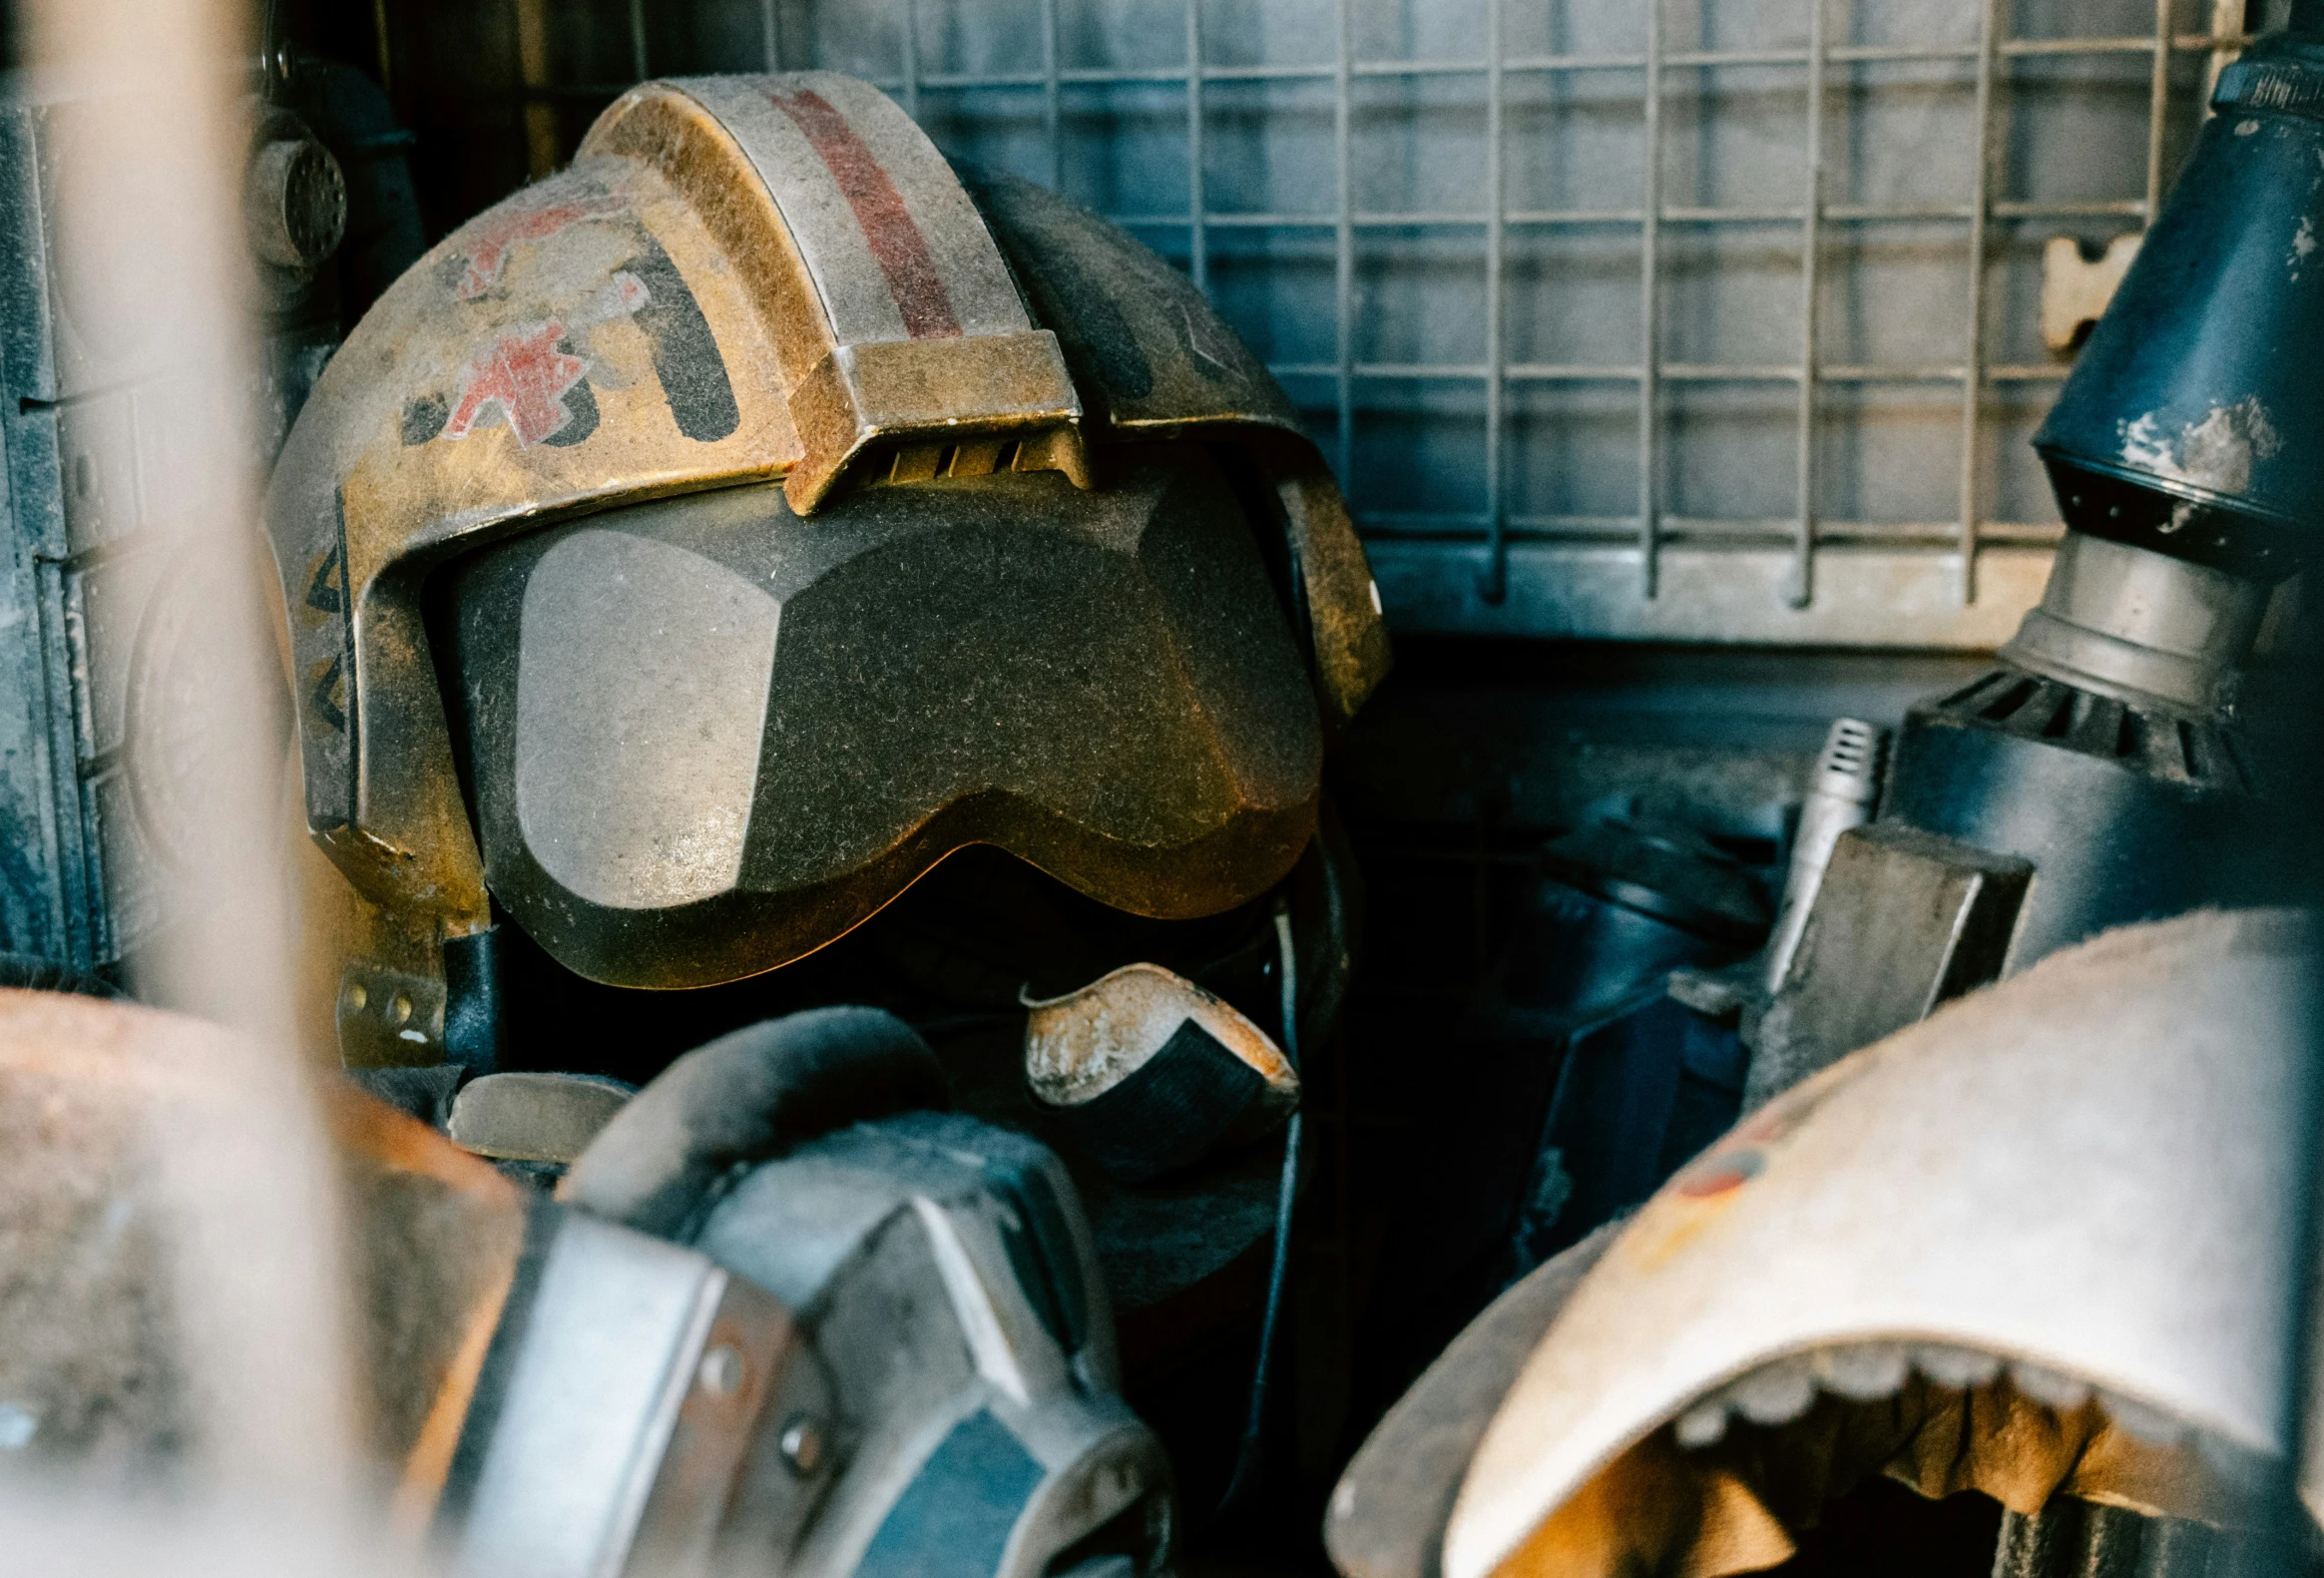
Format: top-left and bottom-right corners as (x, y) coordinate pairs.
(558, 1009), (951, 1241)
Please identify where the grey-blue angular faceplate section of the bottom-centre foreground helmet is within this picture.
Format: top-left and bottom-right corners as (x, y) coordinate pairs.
(679, 1113), (1173, 1578)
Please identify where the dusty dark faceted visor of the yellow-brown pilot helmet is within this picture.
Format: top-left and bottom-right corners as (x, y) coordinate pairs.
(439, 446), (1322, 988)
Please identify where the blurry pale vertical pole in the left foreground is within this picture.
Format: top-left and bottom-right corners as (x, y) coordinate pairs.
(19, 0), (355, 1524)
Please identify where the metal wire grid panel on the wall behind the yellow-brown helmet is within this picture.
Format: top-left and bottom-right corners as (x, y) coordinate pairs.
(381, 0), (2261, 646)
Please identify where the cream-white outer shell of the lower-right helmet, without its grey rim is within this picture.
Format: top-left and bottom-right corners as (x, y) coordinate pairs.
(1446, 913), (2308, 1578)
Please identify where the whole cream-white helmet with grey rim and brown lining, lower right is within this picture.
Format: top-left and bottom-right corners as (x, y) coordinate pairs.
(1327, 911), (2324, 1578)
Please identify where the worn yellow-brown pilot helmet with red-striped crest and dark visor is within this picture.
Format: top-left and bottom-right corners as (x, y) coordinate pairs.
(267, 72), (1387, 988)
